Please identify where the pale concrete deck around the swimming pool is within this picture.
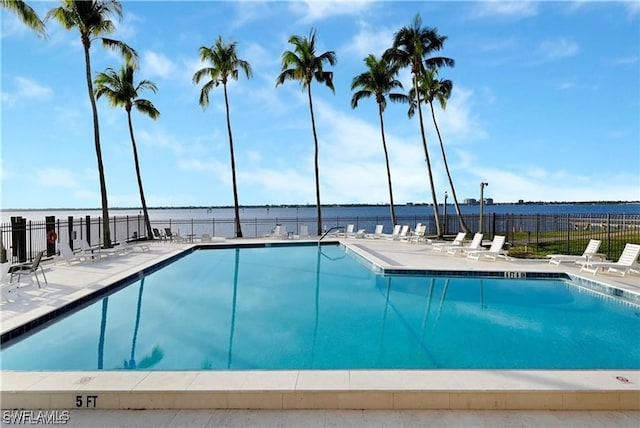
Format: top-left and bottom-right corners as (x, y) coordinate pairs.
(0, 238), (640, 426)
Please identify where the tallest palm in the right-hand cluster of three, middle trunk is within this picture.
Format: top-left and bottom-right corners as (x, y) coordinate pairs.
(383, 14), (455, 237)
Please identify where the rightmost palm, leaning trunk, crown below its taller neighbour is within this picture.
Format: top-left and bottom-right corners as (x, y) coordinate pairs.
(409, 68), (469, 233)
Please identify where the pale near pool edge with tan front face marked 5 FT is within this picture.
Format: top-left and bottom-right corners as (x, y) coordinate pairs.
(0, 370), (640, 410)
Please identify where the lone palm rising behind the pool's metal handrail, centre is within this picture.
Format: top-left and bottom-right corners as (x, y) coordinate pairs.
(276, 28), (337, 235)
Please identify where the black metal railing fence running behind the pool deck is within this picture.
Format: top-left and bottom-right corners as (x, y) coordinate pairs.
(0, 214), (640, 263)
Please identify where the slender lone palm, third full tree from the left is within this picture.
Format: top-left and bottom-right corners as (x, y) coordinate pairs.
(193, 36), (252, 238)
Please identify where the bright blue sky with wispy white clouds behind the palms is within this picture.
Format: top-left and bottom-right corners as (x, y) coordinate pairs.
(0, 1), (640, 208)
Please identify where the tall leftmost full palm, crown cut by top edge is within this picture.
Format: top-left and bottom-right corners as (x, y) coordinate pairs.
(45, 0), (138, 247)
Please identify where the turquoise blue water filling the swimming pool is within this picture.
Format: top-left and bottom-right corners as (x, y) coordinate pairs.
(0, 246), (640, 370)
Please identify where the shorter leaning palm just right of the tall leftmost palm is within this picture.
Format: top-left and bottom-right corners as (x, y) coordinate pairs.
(95, 64), (160, 239)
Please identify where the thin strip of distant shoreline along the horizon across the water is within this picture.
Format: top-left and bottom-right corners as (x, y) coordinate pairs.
(0, 201), (640, 212)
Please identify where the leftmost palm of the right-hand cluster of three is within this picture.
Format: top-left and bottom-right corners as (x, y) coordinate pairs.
(351, 55), (409, 225)
